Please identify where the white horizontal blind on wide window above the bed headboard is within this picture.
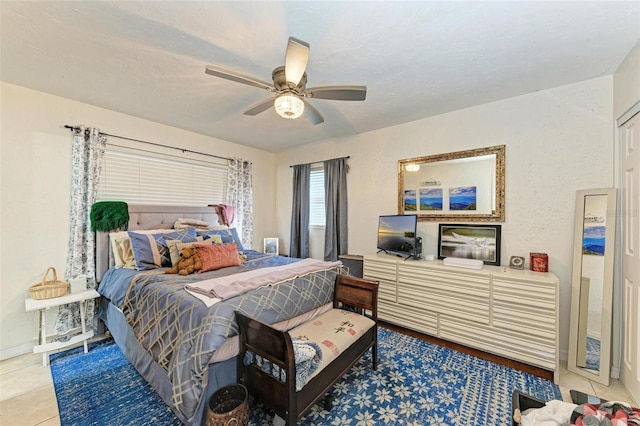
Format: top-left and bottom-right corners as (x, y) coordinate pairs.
(98, 146), (227, 206)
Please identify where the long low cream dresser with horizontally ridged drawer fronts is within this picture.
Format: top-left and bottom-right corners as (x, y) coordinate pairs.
(363, 254), (559, 381)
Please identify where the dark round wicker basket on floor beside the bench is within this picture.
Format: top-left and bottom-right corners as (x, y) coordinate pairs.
(207, 384), (249, 426)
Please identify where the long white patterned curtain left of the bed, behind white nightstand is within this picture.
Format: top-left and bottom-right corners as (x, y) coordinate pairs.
(55, 126), (107, 334)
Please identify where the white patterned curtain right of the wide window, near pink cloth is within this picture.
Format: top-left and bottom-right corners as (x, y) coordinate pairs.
(227, 158), (253, 249)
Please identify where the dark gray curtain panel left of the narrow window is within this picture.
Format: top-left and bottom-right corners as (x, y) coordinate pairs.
(289, 164), (311, 259)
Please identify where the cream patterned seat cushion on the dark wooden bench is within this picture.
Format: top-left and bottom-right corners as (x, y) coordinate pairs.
(289, 309), (375, 379)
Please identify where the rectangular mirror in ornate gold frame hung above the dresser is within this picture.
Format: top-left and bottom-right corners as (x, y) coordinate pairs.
(398, 145), (506, 222)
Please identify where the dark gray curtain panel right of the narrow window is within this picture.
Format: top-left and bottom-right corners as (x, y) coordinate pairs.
(324, 158), (349, 260)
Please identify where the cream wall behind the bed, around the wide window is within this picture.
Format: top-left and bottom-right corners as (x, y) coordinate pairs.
(0, 83), (277, 358)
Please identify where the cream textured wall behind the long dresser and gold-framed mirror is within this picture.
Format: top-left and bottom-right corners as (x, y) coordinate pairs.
(276, 77), (614, 358)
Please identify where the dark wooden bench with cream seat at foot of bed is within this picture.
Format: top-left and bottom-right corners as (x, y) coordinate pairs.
(236, 275), (378, 425)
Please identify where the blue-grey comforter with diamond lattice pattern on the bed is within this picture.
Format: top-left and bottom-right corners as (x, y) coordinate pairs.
(112, 254), (340, 421)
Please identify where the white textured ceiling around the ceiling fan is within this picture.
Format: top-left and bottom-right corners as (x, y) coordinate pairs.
(0, 0), (640, 152)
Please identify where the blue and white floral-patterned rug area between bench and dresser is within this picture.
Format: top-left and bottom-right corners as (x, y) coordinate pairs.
(251, 328), (562, 426)
